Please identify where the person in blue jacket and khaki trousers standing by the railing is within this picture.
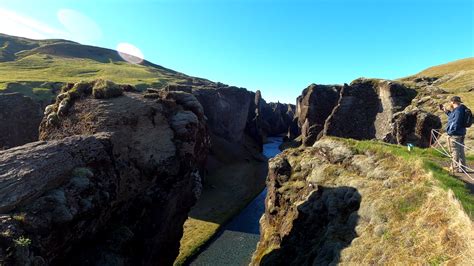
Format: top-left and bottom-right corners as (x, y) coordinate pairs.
(440, 96), (467, 173)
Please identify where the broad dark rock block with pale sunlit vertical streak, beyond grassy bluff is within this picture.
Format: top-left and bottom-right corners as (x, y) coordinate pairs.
(322, 79), (416, 140)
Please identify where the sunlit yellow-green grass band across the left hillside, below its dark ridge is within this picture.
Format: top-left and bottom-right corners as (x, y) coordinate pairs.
(0, 54), (184, 103)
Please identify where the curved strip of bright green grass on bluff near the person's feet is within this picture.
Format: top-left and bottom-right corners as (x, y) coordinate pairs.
(344, 139), (474, 219)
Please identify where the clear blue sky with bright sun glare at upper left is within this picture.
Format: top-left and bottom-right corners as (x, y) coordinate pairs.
(0, 0), (474, 102)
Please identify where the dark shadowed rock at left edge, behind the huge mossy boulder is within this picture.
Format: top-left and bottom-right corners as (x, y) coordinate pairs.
(0, 93), (43, 150)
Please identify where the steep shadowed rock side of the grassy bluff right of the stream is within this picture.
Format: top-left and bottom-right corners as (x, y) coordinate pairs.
(251, 140), (361, 265)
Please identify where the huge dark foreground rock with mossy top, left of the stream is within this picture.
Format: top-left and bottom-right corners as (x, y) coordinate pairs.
(0, 81), (209, 265)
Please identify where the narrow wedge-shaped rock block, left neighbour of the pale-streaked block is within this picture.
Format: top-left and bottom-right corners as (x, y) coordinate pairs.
(296, 84), (342, 146)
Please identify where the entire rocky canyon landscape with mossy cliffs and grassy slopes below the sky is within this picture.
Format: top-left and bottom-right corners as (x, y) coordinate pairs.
(0, 35), (474, 265)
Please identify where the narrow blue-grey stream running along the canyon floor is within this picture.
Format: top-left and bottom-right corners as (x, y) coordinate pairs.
(190, 137), (282, 266)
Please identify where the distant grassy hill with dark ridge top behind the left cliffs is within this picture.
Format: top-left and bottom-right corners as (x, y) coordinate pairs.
(0, 34), (210, 104)
